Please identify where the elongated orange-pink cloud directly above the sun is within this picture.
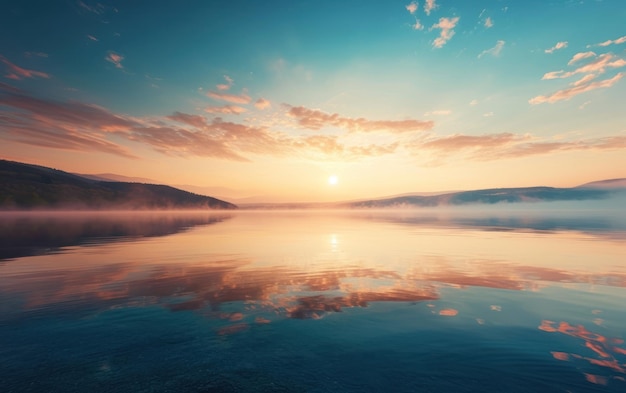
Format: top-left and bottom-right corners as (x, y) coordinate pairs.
(287, 106), (434, 133)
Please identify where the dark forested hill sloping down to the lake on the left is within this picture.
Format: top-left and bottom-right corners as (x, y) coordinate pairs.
(0, 160), (237, 210)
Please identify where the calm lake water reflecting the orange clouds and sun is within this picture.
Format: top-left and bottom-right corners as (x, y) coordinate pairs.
(0, 212), (626, 392)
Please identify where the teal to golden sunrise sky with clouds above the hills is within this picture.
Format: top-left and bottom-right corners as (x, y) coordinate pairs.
(0, 0), (626, 202)
